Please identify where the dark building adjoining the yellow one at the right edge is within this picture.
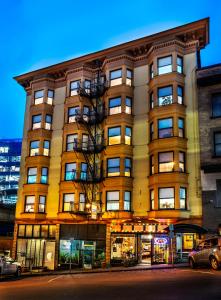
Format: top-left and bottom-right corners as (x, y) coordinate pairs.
(197, 64), (221, 234)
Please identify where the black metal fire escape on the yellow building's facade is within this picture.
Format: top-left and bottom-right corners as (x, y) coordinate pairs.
(74, 62), (108, 218)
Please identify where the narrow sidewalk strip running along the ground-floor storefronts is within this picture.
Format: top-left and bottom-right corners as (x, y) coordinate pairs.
(22, 263), (188, 277)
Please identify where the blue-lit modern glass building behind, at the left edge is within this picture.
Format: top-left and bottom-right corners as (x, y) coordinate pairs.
(0, 139), (22, 204)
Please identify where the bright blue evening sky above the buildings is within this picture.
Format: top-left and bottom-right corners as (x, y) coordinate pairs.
(0, 0), (221, 138)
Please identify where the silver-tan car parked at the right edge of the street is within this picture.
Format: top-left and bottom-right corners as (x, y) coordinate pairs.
(189, 237), (221, 270)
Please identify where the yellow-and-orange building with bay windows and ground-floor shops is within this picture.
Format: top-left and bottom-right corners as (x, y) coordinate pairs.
(13, 19), (209, 269)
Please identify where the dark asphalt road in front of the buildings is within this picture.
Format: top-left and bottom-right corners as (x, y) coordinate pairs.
(0, 268), (221, 300)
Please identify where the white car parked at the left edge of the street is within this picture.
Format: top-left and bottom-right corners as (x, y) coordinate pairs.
(0, 256), (21, 277)
